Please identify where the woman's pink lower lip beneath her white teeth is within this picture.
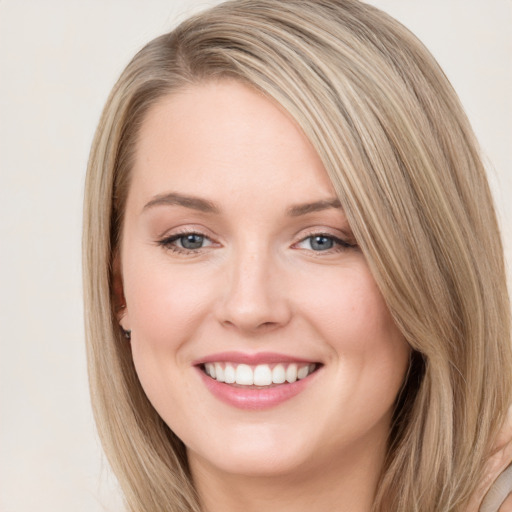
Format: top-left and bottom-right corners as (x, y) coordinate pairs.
(197, 367), (319, 410)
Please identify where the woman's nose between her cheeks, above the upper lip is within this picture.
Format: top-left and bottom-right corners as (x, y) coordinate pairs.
(217, 246), (291, 335)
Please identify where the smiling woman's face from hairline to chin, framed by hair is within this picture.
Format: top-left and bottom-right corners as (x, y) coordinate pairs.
(117, 81), (409, 475)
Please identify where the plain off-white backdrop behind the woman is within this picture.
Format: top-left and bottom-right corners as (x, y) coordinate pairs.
(0, 0), (512, 512)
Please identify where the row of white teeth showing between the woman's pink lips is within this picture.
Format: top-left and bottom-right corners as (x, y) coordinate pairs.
(200, 362), (321, 389)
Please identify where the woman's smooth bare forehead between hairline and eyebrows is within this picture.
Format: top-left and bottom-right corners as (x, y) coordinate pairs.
(132, 81), (334, 208)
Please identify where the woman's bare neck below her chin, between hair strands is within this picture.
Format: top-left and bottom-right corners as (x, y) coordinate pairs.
(189, 432), (385, 512)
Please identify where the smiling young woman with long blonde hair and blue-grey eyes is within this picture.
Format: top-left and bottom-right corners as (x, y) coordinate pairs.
(84, 0), (512, 512)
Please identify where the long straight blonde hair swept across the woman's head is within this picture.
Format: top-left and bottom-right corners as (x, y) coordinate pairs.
(83, 0), (512, 512)
